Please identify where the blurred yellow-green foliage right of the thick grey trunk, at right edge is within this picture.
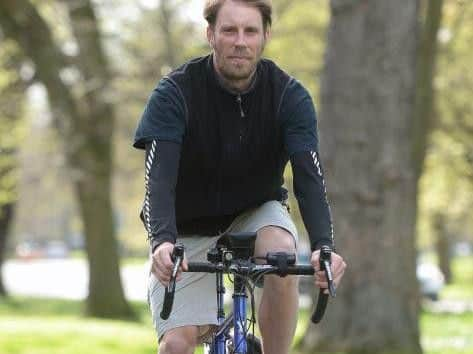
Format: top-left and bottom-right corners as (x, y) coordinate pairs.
(419, 0), (473, 247)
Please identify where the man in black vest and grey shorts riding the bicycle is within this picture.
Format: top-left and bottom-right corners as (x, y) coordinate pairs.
(134, 0), (346, 354)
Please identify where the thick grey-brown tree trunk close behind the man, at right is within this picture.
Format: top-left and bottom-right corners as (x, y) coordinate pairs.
(302, 0), (421, 354)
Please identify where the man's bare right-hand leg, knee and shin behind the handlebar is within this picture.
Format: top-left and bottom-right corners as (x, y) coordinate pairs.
(255, 226), (299, 354)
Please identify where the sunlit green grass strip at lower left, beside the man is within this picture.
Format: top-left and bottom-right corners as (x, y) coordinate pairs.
(0, 298), (155, 354)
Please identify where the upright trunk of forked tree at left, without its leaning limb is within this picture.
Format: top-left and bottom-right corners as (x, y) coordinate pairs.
(65, 0), (132, 317)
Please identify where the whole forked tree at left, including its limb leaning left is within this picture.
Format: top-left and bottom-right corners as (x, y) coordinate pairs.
(0, 0), (132, 317)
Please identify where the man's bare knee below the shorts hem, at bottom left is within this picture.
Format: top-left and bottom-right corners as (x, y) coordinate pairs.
(158, 326), (199, 354)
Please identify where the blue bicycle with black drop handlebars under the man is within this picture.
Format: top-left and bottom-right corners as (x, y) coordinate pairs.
(160, 233), (336, 354)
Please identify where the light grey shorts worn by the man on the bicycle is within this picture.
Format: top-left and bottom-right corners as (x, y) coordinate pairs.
(148, 201), (298, 339)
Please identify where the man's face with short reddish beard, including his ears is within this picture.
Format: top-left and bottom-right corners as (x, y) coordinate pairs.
(207, 0), (269, 81)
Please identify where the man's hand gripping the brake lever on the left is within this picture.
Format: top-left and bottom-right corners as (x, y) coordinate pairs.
(151, 242), (187, 286)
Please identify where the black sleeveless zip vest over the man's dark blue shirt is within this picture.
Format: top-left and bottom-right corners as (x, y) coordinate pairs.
(169, 56), (290, 234)
